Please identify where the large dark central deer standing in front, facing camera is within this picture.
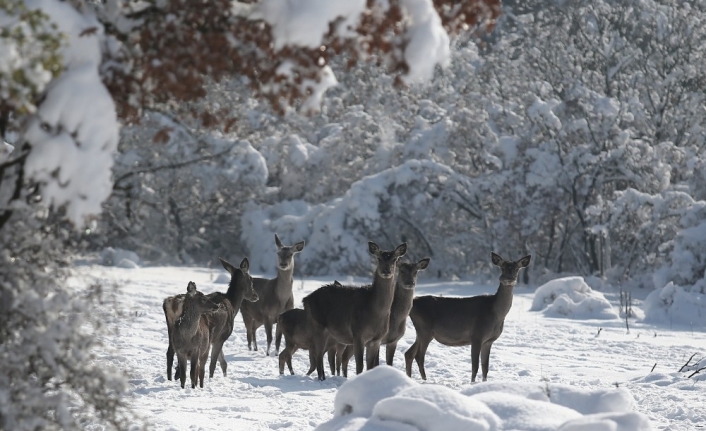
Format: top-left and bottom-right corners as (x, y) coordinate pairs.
(303, 241), (407, 380)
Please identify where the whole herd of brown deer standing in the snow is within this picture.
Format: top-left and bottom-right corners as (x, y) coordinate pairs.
(163, 234), (531, 388)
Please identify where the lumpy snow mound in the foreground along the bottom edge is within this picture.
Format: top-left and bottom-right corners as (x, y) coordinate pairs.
(316, 365), (651, 431)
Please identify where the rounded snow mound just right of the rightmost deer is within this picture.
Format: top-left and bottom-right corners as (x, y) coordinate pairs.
(530, 277), (620, 319)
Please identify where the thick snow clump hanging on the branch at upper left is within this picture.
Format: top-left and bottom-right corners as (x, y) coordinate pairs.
(23, 0), (118, 225)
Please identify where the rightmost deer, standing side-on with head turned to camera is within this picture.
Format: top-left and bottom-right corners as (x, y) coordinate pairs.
(404, 252), (532, 382)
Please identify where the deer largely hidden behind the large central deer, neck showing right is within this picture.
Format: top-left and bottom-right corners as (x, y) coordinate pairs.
(336, 257), (431, 377)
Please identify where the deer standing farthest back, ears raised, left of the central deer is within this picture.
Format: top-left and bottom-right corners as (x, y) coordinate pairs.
(240, 234), (304, 356)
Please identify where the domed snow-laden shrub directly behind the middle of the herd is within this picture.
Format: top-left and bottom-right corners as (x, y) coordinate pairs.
(241, 160), (478, 275)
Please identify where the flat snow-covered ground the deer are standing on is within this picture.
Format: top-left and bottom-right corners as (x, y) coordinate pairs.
(72, 265), (706, 431)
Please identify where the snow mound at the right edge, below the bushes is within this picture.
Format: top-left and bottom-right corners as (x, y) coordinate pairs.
(642, 282), (706, 328)
